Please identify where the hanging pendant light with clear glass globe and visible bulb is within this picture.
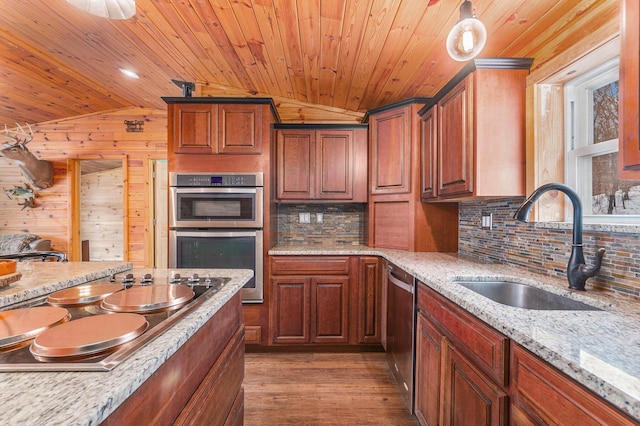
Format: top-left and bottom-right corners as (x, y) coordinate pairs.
(447, 0), (487, 61)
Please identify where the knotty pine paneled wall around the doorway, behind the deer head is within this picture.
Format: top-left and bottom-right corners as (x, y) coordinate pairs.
(0, 108), (167, 267)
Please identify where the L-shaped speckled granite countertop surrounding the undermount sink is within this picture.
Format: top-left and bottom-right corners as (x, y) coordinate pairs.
(269, 245), (640, 420)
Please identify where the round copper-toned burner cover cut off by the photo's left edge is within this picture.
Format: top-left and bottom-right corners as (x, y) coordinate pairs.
(0, 306), (71, 349)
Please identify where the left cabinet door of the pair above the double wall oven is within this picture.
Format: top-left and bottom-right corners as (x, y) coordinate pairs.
(169, 104), (218, 154)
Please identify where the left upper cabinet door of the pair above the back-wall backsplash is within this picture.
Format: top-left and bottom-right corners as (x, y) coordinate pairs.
(276, 130), (315, 200)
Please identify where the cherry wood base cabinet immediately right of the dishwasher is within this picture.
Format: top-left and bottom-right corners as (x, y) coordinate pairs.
(414, 283), (509, 426)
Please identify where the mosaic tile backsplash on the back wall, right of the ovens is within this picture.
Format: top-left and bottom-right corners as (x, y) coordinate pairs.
(278, 204), (366, 245)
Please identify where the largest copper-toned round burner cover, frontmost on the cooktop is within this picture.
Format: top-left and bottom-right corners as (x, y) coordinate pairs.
(29, 314), (149, 360)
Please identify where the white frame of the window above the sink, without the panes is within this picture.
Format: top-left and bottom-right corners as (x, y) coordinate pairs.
(564, 57), (640, 224)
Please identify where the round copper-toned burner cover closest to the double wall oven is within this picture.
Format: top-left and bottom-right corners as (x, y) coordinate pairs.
(101, 284), (194, 313)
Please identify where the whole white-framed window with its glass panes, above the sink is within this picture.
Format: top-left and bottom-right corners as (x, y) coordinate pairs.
(564, 58), (640, 223)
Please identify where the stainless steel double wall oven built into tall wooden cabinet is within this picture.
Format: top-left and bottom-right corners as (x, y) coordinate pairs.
(169, 172), (264, 303)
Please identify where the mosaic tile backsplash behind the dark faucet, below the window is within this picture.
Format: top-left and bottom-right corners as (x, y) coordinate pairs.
(458, 198), (640, 300)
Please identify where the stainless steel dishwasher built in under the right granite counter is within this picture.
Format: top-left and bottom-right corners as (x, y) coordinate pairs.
(387, 263), (415, 413)
